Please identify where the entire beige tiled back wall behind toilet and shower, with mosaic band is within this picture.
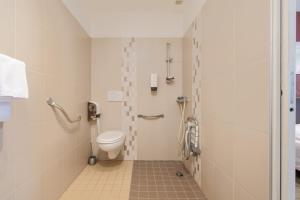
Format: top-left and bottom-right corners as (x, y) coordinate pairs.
(92, 38), (182, 160)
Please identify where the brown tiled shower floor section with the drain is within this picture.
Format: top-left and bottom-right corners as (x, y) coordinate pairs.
(130, 161), (205, 200)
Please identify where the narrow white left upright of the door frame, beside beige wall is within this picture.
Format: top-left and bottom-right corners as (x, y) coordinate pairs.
(269, 0), (282, 200)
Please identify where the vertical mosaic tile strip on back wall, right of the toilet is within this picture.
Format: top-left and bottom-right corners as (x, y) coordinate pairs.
(121, 38), (137, 160)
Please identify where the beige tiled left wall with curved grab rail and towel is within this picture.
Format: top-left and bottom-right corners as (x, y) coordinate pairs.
(0, 0), (90, 200)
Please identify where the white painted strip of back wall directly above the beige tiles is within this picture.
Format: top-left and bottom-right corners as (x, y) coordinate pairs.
(89, 11), (182, 38)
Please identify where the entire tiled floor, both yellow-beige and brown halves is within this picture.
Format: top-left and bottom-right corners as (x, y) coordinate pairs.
(60, 161), (205, 200)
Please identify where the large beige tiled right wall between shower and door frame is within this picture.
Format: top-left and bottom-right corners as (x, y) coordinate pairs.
(183, 0), (270, 200)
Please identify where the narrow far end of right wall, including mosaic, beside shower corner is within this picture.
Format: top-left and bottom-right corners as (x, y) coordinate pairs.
(183, 17), (202, 186)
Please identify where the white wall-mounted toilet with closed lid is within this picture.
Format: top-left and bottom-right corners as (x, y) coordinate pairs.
(96, 131), (125, 159)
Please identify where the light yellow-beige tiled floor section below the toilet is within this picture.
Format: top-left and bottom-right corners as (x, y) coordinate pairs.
(60, 161), (133, 200)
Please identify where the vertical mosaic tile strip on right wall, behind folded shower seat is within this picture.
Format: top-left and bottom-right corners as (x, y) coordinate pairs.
(191, 17), (201, 185)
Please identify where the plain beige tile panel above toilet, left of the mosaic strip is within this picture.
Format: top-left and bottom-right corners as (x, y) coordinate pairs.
(91, 38), (123, 131)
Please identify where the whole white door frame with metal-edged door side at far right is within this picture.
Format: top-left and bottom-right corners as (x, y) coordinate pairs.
(270, 0), (296, 200)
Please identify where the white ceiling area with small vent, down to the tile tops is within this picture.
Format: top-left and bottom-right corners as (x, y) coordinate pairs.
(63, 0), (204, 38)
